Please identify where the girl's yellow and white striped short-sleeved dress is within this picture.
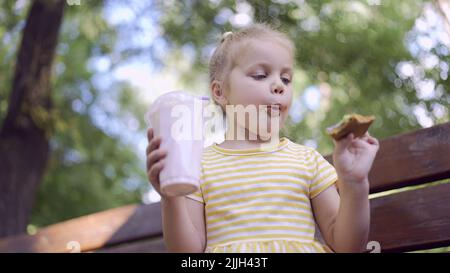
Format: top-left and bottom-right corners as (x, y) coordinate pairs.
(187, 138), (337, 253)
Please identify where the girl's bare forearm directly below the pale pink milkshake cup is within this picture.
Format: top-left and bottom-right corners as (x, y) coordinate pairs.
(161, 196), (206, 252)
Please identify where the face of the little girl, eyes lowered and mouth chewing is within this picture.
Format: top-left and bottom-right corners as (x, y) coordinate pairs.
(226, 39), (294, 137)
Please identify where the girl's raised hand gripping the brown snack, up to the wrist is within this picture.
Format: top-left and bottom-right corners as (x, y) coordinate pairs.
(333, 132), (380, 183)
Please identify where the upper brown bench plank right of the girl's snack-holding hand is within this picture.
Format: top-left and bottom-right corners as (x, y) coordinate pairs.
(325, 122), (450, 193)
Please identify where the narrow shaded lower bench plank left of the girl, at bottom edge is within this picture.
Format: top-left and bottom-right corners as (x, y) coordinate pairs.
(94, 237), (167, 253)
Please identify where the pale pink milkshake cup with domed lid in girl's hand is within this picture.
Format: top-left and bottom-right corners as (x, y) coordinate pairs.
(146, 91), (209, 196)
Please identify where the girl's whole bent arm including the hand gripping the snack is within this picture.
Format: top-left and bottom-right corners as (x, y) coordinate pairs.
(312, 132), (379, 252)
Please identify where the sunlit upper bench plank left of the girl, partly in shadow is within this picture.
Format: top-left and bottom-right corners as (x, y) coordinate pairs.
(0, 203), (162, 252)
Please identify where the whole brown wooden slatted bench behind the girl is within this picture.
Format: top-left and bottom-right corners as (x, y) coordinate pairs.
(0, 123), (450, 252)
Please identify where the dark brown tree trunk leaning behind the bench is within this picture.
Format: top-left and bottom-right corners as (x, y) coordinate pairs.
(0, 0), (65, 237)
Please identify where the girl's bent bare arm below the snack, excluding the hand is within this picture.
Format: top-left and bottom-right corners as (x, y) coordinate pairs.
(312, 181), (370, 252)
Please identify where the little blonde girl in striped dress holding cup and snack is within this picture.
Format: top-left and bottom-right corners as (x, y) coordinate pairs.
(147, 24), (379, 252)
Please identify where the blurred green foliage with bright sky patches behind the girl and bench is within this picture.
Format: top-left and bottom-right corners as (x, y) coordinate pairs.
(0, 0), (450, 241)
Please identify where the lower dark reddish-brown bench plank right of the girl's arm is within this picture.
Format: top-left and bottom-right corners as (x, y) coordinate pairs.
(369, 183), (450, 252)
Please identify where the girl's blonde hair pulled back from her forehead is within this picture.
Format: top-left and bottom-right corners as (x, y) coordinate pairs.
(209, 23), (295, 110)
